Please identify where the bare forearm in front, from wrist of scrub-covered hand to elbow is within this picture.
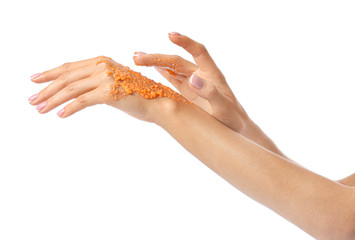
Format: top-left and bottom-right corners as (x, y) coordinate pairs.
(157, 101), (355, 238)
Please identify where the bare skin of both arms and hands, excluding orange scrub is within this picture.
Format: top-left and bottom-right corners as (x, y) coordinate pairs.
(31, 33), (355, 240)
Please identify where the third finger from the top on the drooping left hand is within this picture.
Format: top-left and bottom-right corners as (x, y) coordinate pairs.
(39, 76), (98, 113)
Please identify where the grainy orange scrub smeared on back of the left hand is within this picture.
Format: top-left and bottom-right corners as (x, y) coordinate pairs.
(97, 57), (189, 103)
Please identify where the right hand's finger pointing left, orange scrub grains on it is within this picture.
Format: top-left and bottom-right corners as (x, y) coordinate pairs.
(133, 53), (197, 76)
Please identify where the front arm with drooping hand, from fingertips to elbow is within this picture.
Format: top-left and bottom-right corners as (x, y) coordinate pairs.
(29, 47), (355, 239)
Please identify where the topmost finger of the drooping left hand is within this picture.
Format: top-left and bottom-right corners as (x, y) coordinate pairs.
(31, 57), (102, 83)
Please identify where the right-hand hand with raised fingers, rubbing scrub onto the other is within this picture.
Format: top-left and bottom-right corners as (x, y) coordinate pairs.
(134, 33), (248, 132)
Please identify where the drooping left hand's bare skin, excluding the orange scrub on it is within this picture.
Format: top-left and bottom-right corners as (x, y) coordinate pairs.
(29, 57), (171, 121)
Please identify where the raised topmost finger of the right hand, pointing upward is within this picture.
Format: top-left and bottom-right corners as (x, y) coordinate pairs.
(169, 33), (218, 71)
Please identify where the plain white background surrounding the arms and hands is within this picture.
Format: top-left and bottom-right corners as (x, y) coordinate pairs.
(0, 0), (355, 240)
